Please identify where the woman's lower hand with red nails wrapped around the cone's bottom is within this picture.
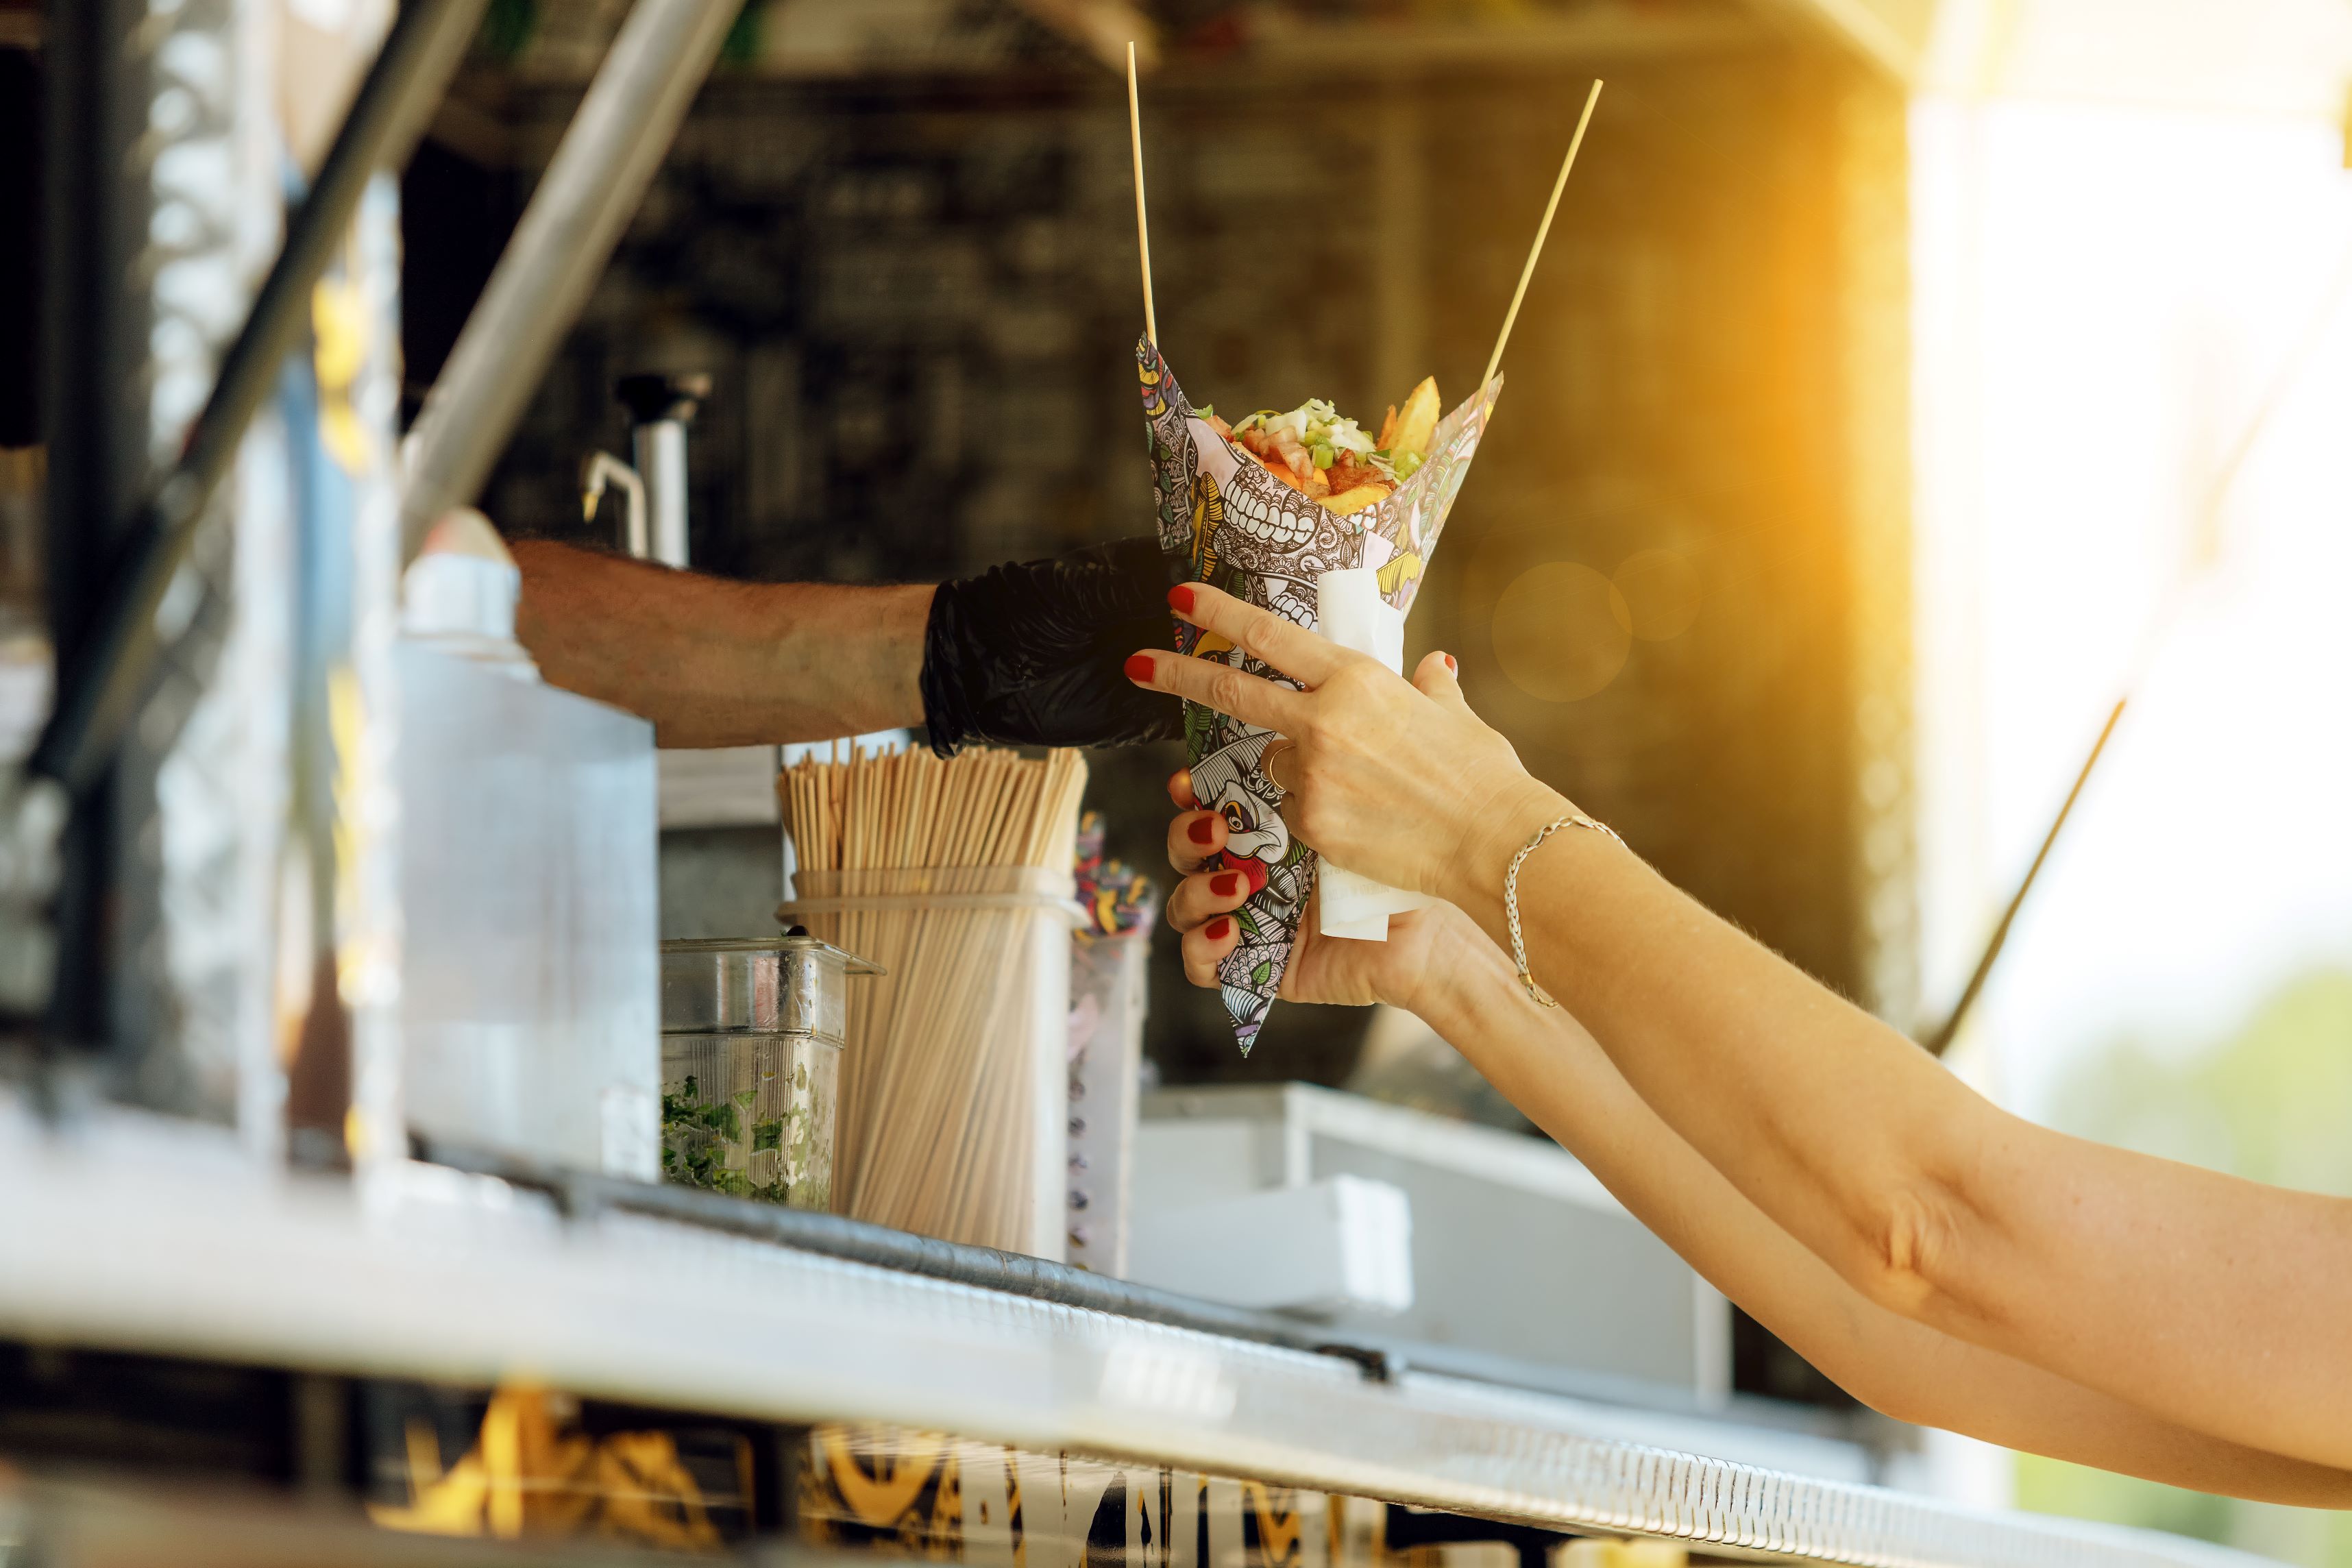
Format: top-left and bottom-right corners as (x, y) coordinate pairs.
(1169, 771), (1486, 1011)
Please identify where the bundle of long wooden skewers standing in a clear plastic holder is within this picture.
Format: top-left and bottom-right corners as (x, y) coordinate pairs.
(776, 750), (1087, 1258)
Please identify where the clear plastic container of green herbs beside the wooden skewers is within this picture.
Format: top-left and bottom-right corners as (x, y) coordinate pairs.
(661, 935), (882, 1208)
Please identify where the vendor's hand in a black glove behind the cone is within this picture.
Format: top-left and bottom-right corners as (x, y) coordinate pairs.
(922, 539), (1183, 757)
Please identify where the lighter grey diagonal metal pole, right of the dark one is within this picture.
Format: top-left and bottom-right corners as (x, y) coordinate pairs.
(400, 0), (744, 559)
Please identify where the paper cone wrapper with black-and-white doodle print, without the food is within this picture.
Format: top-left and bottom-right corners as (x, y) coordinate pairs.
(1136, 339), (1503, 1055)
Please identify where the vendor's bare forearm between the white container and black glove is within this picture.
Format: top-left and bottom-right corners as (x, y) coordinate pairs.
(513, 541), (931, 748)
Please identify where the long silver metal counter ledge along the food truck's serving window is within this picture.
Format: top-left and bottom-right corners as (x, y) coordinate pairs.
(0, 1103), (2255, 1568)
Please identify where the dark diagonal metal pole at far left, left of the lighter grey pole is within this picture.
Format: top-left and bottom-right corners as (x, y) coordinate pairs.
(31, 0), (485, 792)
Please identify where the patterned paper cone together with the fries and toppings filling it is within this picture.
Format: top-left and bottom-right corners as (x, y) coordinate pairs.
(1136, 336), (1503, 1055)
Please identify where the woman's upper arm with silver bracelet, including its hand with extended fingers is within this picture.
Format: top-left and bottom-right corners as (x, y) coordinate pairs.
(1129, 585), (2352, 1467)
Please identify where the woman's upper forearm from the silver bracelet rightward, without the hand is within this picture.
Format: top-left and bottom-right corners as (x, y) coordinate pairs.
(1454, 797), (2352, 1467)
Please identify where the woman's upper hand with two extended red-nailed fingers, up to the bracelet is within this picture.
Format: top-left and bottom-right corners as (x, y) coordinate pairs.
(1127, 583), (1569, 898)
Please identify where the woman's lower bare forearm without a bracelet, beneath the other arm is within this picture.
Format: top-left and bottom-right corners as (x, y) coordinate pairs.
(1414, 922), (2352, 1507)
